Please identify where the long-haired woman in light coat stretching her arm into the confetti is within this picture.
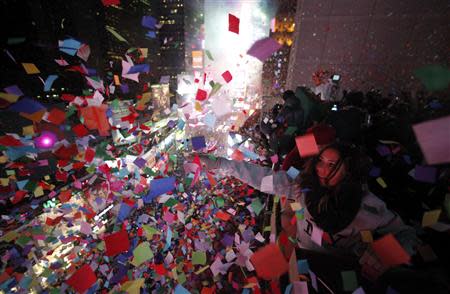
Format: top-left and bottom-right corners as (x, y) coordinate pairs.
(190, 144), (426, 292)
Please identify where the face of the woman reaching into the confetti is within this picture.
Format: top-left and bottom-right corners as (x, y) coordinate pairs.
(316, 148), (346, 187)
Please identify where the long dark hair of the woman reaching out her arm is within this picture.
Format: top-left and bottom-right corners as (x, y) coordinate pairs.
(297, 143), (370, 234)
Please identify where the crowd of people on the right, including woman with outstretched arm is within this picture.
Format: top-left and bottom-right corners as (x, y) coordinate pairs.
(206, 87), (450, 293)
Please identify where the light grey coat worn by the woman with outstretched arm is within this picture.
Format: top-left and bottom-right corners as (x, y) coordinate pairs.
(210, 158), (418, 254)
